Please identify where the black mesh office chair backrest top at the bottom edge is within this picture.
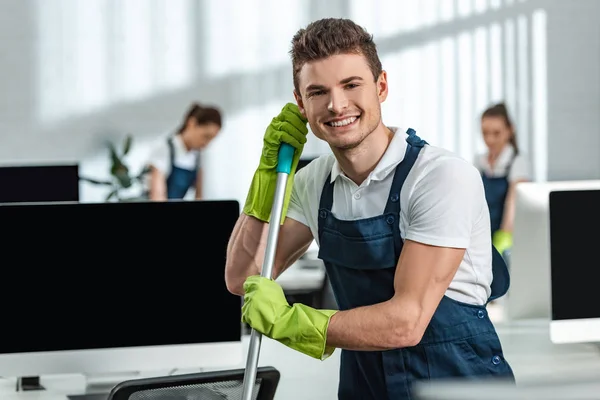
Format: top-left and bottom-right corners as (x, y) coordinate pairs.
(108, 367), (280, 400)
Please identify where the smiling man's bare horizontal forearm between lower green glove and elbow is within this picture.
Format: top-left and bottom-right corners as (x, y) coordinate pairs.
(327, 299), (421, 351)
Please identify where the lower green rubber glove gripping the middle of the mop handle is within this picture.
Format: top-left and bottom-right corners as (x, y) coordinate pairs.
(242, 275), (337, 360)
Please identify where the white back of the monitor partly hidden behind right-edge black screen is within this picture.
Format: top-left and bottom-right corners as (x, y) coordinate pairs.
(503, 180), (600, 321)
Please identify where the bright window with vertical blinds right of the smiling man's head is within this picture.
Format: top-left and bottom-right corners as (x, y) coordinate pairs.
(350, 0), (547, 180)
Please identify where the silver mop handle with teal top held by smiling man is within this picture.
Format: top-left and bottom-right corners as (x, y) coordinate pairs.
(242, 143), (295, 400)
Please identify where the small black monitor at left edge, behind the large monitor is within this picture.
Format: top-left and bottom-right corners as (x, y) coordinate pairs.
(0, 164), (79, 203)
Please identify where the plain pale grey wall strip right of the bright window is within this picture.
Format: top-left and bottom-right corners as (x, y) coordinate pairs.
(541, 0), (600, 180)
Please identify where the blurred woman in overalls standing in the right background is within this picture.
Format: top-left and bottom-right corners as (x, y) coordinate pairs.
(475, 103), (531, 258)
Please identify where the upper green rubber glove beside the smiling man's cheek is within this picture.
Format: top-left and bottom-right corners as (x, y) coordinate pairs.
(244, 103), (308, 223)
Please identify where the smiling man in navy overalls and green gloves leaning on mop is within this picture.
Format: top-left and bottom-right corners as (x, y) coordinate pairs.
(226, 19), (513, 399)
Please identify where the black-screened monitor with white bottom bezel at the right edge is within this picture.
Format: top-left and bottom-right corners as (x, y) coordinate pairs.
(550, 189), (600, 343)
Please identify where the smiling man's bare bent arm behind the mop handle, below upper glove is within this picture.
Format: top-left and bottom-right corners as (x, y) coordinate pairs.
(225, 213), (313, 296)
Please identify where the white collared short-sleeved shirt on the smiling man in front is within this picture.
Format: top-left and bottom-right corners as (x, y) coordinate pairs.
(287, 128), (492, 305)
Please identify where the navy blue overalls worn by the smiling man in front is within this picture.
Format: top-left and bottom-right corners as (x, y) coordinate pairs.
(318, 129), (514, 400)
